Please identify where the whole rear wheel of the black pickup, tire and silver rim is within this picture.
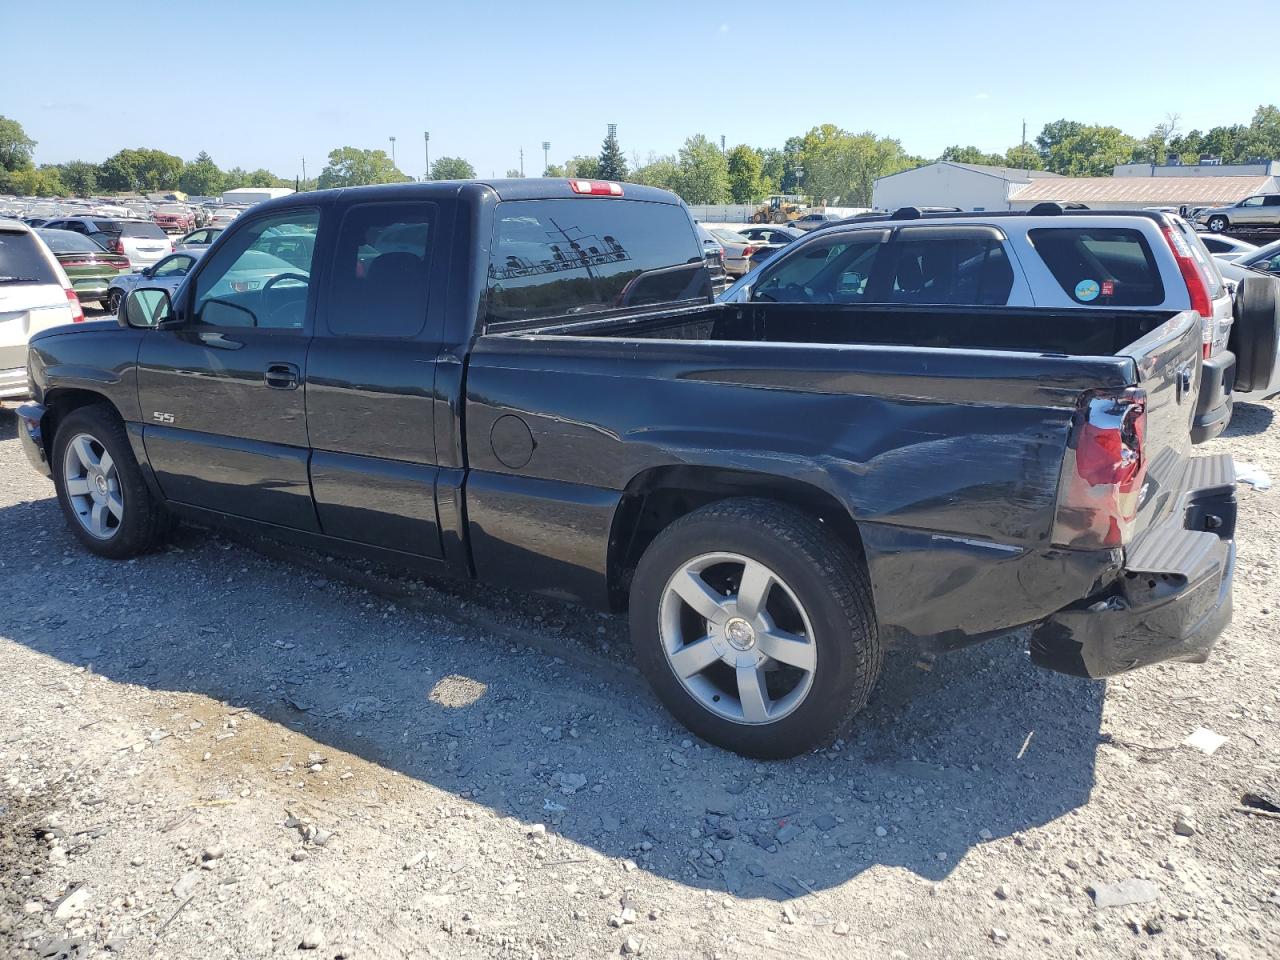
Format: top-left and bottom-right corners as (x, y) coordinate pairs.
(631, 499), (882, 759)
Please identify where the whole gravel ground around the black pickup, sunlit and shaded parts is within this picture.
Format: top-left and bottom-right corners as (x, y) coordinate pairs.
(0, 402), (1280, 960)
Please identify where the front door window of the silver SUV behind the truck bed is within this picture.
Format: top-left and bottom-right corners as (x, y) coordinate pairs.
(751, 230), (888, 303)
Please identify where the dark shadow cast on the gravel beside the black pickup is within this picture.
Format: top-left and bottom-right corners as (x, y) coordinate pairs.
(0, 447), (1103, 900)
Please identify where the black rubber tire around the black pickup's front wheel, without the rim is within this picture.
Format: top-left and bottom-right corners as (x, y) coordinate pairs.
(51, 406), (154, 559)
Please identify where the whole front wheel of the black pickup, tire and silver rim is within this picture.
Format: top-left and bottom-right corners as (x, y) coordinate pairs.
(51, 406), (169, 559)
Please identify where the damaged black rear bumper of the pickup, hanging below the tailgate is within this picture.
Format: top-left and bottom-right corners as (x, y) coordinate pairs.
(1030, 456), (1236, 677)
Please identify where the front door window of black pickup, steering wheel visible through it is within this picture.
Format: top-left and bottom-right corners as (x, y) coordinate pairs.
(192, 209), (320, 332)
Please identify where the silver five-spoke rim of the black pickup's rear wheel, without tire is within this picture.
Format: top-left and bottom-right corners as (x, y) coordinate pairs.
(658, 553), (818, 724)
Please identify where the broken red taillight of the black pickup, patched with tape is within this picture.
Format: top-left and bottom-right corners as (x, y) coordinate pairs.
(1053, 388), (1147, 549)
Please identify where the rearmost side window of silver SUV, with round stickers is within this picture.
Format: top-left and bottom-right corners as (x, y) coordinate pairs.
(1027, 227), (1165, 307)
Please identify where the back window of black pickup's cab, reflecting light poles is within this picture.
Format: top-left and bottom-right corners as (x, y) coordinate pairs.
(488, 197), (710, 323)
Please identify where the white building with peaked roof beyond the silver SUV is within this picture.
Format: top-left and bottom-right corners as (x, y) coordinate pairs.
(872, 160), (1066, 210)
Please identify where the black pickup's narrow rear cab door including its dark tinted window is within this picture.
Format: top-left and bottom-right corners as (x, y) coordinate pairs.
(306, 191), (452, 558)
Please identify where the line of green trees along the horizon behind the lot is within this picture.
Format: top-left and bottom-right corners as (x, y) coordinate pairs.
(0, 105), (1280, 206)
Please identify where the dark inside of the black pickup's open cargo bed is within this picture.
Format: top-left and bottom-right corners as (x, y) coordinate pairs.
(526, 303), (1171, 357)
